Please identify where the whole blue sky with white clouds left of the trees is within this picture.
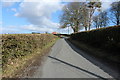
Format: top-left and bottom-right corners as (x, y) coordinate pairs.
(0, 0), (119, 33)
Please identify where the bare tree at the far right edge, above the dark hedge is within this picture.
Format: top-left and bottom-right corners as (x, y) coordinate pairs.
(110, 1), (120, 25)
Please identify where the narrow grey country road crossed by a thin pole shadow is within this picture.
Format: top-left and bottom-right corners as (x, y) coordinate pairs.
(33, 39), (111, 79)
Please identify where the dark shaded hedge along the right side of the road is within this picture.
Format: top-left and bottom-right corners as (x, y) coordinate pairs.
(70, 26), (120, 53)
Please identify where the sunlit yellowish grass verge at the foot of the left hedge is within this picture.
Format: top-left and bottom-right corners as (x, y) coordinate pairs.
(2, 35), (58, 78)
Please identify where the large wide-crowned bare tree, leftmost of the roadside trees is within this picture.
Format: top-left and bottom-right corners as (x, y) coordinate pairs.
(60, 2), (88, 32)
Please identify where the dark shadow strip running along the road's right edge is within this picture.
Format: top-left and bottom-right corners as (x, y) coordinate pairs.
(65, 39), (119, 78)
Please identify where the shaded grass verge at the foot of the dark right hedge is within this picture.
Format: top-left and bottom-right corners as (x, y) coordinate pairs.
(68, 39), (120, 74)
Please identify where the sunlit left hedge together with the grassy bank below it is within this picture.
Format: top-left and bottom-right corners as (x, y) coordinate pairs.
(2, 34), (58, 77)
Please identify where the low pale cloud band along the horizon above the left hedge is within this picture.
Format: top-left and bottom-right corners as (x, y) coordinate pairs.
(0, 25), (73, 34)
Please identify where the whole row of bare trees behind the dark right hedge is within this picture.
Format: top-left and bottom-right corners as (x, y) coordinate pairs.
(60, 1), (120, 32)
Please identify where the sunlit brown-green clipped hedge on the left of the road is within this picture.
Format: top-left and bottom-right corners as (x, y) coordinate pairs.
(2, 34), (56, 66)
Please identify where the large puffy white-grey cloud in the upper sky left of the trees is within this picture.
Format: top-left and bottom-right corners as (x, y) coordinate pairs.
(13, 0), (63, 32)
